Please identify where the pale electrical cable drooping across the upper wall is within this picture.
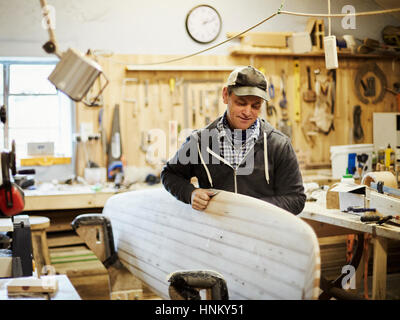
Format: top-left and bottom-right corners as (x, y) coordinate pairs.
(97, 1), (400, 66)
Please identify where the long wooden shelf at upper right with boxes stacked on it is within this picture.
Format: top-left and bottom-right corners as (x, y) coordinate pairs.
(229, 46), (400, 59)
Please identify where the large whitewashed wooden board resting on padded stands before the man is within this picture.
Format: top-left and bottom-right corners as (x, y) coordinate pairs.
(103, 188), (320, 300)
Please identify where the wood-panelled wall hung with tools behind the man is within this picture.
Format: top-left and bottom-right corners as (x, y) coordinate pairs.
(76, 55), (400, 175)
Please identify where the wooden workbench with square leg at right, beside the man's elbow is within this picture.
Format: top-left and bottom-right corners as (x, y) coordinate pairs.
(299, 202), (400, 300)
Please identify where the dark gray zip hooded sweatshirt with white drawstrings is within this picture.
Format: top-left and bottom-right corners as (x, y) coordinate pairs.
(161, 118), (306, 214)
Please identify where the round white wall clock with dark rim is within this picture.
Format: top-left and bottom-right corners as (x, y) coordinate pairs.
(186, 5), (222, 43)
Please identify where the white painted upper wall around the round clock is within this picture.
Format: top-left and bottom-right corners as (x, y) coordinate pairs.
(0, 0), (398, 56)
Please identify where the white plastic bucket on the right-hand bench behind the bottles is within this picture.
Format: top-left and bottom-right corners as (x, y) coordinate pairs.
(331, 144), (374, 179)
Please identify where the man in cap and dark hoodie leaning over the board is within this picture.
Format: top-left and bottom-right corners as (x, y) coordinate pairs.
(161, 66), (306, 214)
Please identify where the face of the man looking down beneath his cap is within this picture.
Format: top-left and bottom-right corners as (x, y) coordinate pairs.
(222, 87), (264, 130)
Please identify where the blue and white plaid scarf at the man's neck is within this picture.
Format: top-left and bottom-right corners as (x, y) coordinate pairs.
(217, 112), (260, 169)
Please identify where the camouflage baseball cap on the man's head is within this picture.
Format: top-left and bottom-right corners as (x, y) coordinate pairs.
(226, 66), (269, 101)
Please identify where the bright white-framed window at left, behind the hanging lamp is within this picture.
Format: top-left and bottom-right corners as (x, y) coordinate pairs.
(0, 61), (73, 166)
